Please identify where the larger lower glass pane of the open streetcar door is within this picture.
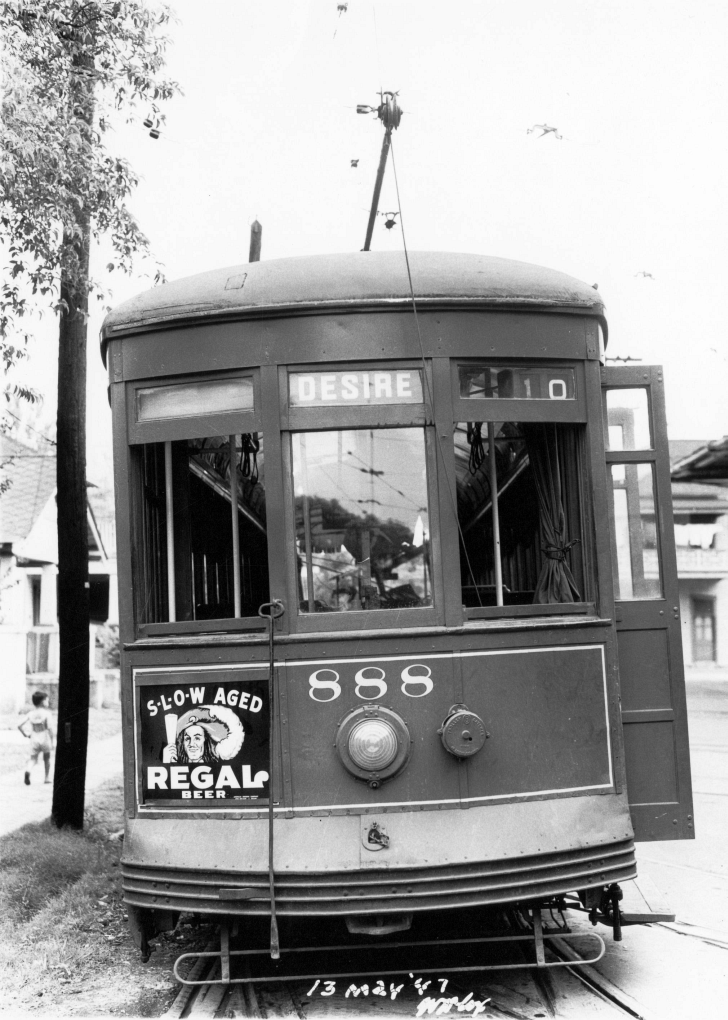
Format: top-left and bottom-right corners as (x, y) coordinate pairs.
(611, 464), (662, 601)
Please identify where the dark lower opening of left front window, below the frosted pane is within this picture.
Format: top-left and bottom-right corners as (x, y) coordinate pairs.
(137, 432), (269, 623)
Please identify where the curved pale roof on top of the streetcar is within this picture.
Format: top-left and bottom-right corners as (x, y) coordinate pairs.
(101, 252), (604, 344)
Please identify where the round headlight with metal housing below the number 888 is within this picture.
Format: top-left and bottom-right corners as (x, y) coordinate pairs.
(335, 705), (412, 789)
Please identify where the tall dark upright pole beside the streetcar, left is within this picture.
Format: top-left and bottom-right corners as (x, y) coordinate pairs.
(52, 216), (91, 828)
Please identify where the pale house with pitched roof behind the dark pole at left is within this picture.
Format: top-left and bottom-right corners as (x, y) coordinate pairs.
(0, 436), (118, 712)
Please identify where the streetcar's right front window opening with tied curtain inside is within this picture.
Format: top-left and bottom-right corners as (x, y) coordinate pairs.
(455, 421), (584, 608)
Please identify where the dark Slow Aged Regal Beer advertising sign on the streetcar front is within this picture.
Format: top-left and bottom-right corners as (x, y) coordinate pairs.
(135, 668), (270, 808)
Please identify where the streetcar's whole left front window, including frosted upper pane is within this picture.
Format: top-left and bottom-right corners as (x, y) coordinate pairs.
(127, 374), (269, 625)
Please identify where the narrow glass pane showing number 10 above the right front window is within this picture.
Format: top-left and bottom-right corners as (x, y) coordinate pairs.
(459, 365), (576, 400)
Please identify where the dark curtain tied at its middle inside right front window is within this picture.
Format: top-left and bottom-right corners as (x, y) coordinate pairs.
(521, 423), (581, 605)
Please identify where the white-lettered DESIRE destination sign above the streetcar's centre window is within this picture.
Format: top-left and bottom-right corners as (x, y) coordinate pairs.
(289, 368), (422, 407)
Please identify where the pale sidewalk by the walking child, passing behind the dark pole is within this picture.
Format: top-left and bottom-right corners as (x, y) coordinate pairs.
(0, 733), (122, 835)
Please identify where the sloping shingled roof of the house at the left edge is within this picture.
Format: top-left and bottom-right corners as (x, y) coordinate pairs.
(0, 436), (56, 543)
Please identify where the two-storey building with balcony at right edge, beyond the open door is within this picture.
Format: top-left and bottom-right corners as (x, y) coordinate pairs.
(670, 437), (728, 666)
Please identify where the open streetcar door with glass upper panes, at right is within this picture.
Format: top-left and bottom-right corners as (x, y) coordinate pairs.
(602, 365), (694, 840)
